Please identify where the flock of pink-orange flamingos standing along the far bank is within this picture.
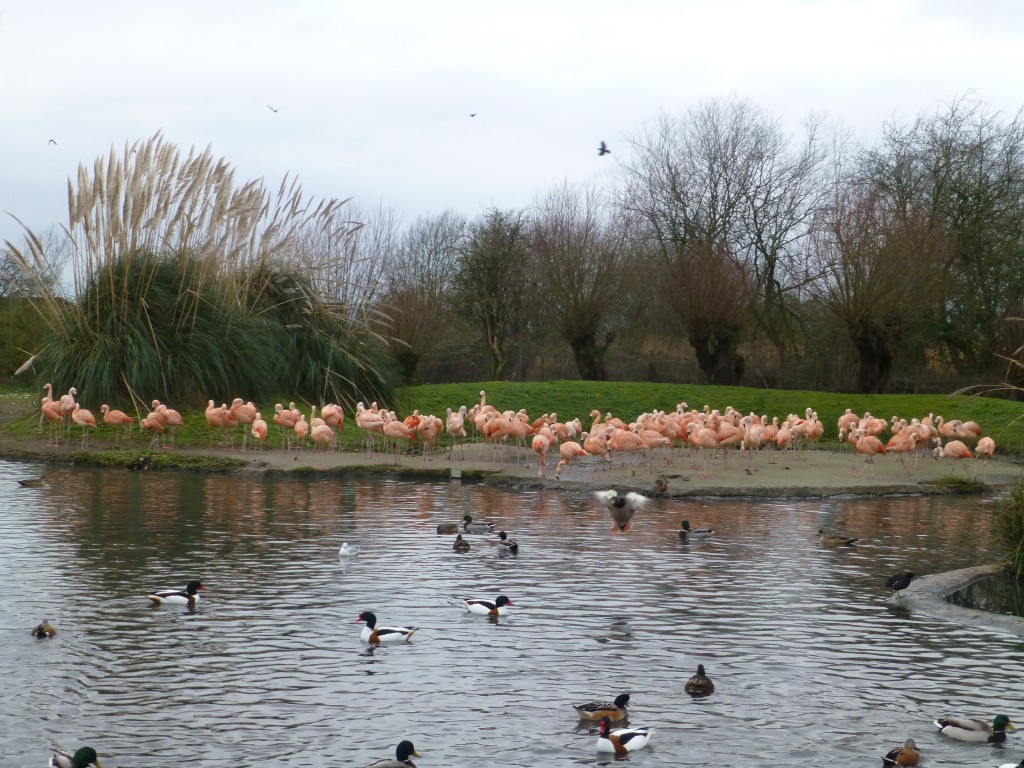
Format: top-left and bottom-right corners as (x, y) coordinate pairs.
(32, 383), (995, 478)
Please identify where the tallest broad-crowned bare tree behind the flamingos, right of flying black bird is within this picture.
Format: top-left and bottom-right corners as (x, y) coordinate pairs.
(623, 100), (825, 384)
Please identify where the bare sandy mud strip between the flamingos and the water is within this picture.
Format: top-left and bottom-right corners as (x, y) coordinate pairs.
(9, 433), (1024, 497)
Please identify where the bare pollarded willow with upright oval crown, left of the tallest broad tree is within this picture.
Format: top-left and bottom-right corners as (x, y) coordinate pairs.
(529, 183), (637, 381)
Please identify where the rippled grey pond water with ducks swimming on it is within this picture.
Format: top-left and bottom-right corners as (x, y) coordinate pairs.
(0, 463), (1024, 768)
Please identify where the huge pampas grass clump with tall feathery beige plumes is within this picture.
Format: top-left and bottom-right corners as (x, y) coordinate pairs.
(6, 133), (391, 410)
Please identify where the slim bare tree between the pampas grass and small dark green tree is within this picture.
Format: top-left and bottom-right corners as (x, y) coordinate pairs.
(384, 212), (466, 382)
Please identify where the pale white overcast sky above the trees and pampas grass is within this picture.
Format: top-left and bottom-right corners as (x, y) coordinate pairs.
(0, 0), (1024, 243)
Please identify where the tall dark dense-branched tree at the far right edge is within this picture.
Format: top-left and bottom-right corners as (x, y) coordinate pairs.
(859, 96), (1024, 373)
